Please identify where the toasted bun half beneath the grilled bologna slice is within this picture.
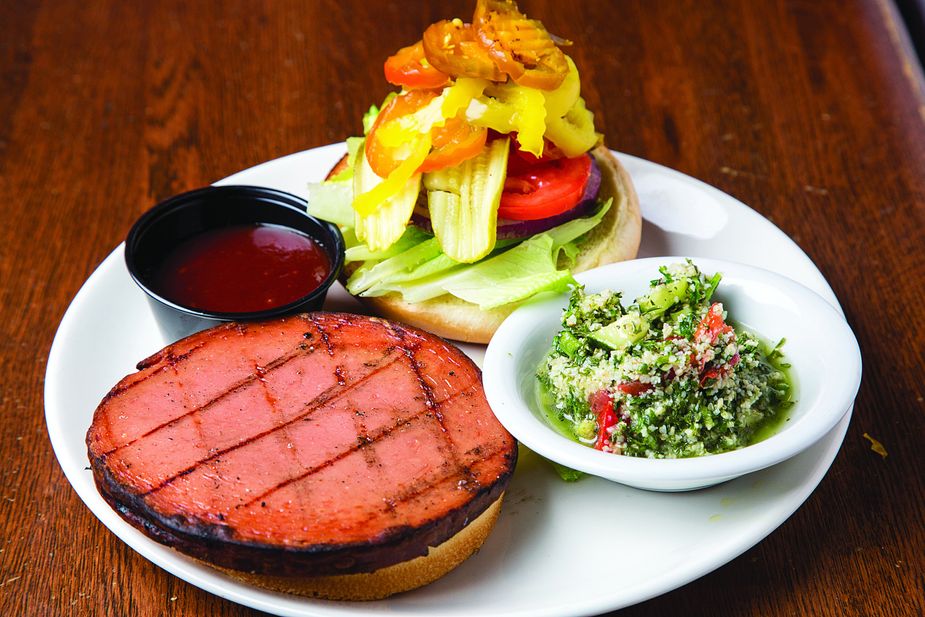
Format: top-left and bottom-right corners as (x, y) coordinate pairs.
(210, 494), (504, 600)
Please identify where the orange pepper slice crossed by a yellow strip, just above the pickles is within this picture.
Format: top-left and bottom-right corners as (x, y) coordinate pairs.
(366, 90), (488, 178)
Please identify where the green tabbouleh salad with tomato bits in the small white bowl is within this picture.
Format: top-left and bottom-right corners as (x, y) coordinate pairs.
(537, 260), (792, 458)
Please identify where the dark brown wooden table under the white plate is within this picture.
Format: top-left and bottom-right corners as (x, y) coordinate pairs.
(0, 0), (925, 616)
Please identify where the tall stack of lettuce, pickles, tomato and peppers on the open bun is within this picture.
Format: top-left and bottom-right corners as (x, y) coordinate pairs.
(309, 0), (620, 309)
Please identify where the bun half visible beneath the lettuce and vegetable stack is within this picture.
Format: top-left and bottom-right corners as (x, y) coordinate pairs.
(332, 145), (642, 344)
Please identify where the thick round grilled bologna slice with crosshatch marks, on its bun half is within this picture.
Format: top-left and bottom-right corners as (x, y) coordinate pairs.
(87, 313), (517, 599)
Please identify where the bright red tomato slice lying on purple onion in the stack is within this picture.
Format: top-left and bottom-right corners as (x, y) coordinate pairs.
(498, 155), (591, 221)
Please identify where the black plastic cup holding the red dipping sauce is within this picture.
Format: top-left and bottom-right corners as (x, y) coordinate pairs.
(125, 186), (344, 342)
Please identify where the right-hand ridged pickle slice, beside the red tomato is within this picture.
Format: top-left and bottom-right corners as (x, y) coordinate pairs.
(424, 138), (509, 263)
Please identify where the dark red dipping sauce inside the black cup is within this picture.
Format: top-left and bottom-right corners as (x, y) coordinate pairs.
(151, 224), (331, 313)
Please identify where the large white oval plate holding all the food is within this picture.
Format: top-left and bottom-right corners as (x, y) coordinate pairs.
(45, 145), (851, 617)
